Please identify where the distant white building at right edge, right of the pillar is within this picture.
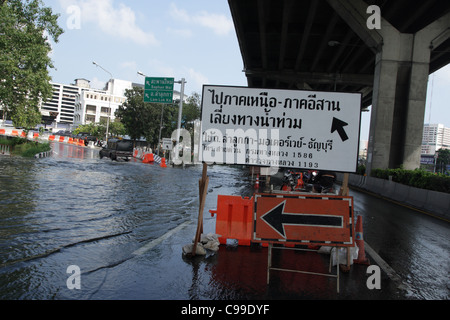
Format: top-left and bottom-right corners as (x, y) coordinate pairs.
(421, 123), (450, 156)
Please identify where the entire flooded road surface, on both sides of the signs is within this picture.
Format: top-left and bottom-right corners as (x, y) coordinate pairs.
(0, 143), (450, 300)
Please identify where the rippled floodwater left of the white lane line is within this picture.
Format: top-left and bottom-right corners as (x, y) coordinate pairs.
(0, 143), (250, 299)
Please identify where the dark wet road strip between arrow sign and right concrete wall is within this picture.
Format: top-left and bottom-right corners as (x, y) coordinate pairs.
(350, 190), (450, 300)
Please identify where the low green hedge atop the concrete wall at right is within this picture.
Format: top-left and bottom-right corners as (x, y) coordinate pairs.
(370, 169), (450, 193)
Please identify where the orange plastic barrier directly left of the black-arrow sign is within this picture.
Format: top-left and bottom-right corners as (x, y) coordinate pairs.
(209, 195), (254, 246)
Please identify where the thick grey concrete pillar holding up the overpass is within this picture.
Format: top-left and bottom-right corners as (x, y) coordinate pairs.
(367, 14), (450, 173)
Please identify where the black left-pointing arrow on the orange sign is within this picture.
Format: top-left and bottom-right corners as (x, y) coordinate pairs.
(261, 200), (343, 238)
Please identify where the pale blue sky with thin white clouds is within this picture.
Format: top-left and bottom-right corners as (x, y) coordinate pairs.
(43, 0), (450, 140)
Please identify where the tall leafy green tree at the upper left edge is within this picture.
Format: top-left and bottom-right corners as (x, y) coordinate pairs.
(0, 0), (63, 128)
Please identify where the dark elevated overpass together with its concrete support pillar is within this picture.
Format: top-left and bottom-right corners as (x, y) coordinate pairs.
(228, 0), (450, 171)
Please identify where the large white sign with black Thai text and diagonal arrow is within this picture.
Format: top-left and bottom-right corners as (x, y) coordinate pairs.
(200, 85), (361, 172)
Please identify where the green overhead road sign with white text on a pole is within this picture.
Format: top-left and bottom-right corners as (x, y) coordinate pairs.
(144, 77), (174, 103)
